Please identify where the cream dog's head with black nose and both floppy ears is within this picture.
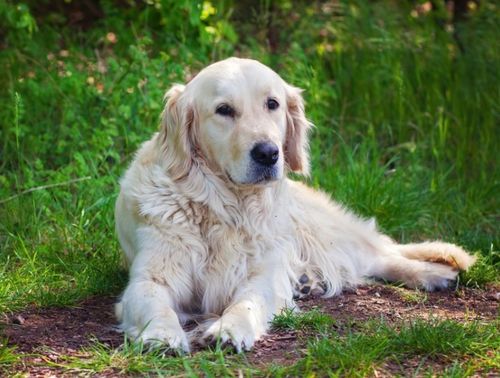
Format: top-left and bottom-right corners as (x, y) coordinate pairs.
(161, 58), (311, 185)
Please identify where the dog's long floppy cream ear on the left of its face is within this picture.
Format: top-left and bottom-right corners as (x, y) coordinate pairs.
(160, 84), (196, 180)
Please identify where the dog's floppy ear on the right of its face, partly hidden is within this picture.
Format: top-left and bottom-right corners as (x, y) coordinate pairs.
(285, 85), (312, 176)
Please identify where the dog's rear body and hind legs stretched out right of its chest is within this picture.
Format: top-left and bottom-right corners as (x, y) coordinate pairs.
(291, 183), (475, 296)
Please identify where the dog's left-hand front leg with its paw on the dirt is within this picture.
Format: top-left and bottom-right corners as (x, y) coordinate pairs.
(116, 225), (203, 352)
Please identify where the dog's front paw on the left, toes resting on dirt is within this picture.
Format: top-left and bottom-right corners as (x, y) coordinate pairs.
(126, 323), (190, 353)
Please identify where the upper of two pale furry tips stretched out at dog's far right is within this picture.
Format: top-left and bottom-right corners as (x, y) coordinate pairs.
(397, 241), (476, 270)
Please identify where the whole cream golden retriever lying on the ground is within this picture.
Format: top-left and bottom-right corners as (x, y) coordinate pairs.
(115, 58), (475, 352)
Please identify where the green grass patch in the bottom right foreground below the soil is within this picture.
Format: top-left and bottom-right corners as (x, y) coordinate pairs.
(275, 321), (500, 376)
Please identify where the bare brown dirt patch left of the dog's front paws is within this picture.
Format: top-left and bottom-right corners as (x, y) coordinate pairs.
(0, 297), (123, 377)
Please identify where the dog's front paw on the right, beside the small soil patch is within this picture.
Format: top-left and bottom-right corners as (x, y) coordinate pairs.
(202, 315), (263, 353)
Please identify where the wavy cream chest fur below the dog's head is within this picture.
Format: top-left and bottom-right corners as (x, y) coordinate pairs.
(136, 161), (293, 314)
